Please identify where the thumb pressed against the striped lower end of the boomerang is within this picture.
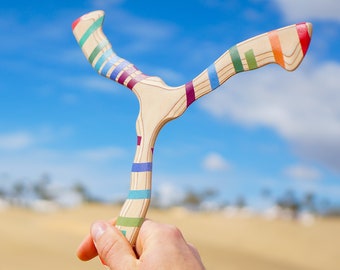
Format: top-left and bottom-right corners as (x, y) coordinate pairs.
(91, 221), (137, 270)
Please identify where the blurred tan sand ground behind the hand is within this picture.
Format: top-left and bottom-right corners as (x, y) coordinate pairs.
(0, 205), (340, 270)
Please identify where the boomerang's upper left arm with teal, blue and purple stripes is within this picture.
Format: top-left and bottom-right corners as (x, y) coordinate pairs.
(72, 10), (148, 90)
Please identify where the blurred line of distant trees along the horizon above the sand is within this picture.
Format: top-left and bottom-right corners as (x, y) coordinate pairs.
(0, 174), (340, 217)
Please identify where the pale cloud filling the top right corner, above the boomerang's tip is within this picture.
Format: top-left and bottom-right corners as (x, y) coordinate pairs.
(275, 0), (340, 21)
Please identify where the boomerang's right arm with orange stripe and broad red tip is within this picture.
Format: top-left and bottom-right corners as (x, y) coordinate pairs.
(185, 23), (312, 105)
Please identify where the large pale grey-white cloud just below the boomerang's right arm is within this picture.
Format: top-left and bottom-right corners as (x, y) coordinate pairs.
(201, 60), (340, 171)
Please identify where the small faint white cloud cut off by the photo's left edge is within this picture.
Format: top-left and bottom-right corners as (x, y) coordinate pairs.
(0, 132), (34, 150)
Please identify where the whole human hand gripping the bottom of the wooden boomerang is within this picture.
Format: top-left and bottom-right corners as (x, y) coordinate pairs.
(77, 220), (205, 270)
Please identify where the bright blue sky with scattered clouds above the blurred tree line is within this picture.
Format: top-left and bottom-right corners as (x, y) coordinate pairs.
(0, 0), (340, 208)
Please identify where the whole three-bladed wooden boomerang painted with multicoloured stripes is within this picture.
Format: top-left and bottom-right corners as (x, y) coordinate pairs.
(72, 10), (312, 245)
